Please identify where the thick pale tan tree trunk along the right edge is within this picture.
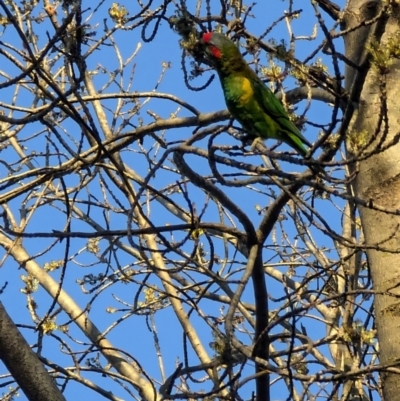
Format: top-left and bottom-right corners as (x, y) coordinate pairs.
(344, 0), (400, 401)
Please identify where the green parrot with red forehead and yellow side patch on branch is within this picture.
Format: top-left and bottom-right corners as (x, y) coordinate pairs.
(202, 32), (311, 156)
